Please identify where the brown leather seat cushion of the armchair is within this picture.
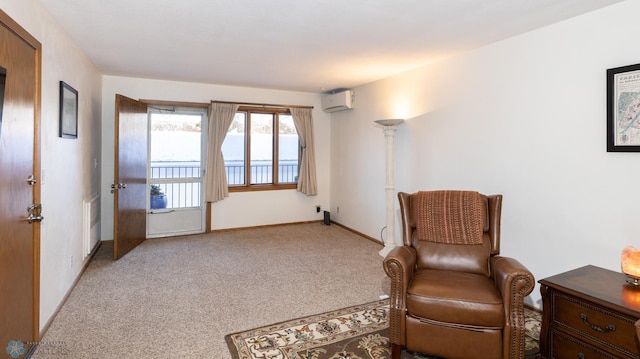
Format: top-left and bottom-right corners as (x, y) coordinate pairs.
(407, 269), (505, 328)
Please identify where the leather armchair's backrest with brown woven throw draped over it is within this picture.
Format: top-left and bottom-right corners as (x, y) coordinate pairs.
(399, 191), (502, 276)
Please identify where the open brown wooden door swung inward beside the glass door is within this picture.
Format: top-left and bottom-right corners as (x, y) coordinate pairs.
(111, 95), (148, 260)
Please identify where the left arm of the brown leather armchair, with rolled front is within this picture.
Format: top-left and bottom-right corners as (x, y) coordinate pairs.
(382, 246), (416, 345)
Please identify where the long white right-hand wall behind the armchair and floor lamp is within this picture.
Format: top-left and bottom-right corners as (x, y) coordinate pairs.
(331, 1), (640, 307)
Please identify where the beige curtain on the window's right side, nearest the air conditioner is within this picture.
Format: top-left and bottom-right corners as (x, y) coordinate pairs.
(290, 107), (318, 196)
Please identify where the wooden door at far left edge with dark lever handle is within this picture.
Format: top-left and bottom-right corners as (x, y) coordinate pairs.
(0, 10), (41, 355)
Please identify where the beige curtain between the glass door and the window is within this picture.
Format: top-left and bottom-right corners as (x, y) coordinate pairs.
(205, 102), (239, 202)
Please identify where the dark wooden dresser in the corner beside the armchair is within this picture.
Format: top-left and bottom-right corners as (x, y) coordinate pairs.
(539, 265), (640, 359)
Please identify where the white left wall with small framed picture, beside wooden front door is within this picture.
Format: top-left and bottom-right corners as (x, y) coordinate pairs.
(0, 0), (101, 329)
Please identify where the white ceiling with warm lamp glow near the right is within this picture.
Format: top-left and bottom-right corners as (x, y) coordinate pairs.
(40, 0), (622, 93)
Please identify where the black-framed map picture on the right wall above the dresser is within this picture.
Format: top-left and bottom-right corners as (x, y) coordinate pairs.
(607, 64), (640, 152)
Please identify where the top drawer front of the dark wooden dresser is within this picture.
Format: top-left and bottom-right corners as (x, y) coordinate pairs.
(552, 293), (638, 358)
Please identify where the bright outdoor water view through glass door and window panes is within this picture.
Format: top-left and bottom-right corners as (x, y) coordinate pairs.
(149, 111), (299, 209)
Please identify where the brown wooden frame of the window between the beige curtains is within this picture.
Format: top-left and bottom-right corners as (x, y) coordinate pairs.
(227, 105), (300, 192)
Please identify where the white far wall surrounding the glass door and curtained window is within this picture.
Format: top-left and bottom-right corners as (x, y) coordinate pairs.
(102, 76), (331, 240)
